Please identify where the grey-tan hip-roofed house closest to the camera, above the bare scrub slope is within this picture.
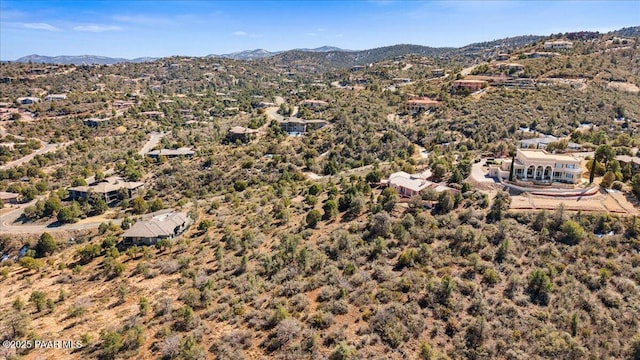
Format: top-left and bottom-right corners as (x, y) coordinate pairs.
(122, 212), (193, 246)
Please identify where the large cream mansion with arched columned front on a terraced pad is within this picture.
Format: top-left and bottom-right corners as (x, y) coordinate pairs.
(489, 149), (582, 184)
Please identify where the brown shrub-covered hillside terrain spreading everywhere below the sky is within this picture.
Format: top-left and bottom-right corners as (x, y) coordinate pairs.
(0, 32), (640, 359)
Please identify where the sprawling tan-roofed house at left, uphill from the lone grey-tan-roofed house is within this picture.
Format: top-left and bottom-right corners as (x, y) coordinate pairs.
(69, 176), (144, 204)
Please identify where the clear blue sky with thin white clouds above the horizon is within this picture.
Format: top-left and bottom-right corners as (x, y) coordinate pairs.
(0, 0), (640, 60)
